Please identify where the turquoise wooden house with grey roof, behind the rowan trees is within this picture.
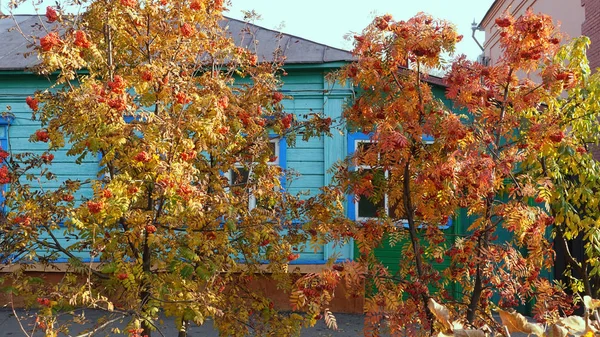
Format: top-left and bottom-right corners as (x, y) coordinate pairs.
(0, 15), (464, 312)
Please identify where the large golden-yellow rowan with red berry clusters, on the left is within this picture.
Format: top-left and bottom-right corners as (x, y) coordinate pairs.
(2, 0), (329, 336)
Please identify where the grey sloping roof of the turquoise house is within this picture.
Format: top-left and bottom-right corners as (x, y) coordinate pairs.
(0, 15), (354, 71)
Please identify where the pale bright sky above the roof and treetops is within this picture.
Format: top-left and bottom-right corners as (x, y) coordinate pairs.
(7, 0), (494, 60)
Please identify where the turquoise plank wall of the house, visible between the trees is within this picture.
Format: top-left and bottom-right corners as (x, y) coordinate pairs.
(0, 64), (353, 264)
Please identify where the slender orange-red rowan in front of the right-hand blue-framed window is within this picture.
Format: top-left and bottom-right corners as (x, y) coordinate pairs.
(292, 13), (468, 335)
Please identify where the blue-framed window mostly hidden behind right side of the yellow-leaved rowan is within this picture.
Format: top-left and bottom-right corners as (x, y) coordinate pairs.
(228, 139), (286, 210)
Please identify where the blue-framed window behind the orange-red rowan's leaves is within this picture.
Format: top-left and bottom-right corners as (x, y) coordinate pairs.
(347, 132), (452, 229)
